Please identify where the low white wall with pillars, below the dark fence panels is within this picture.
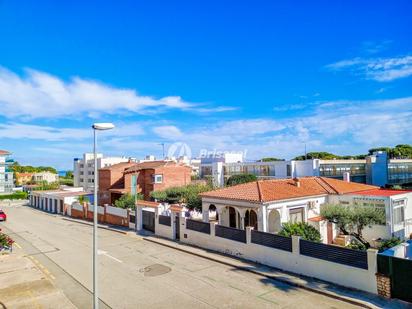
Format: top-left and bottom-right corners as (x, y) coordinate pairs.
(179, 220), (377, 294)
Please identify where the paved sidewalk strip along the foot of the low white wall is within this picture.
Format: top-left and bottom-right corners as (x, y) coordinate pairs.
(142, 236), (411, 308)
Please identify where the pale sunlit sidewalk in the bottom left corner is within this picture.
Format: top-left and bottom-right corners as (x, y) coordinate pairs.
(0, 244), (76, 309)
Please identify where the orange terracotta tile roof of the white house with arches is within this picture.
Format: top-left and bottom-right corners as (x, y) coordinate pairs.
(201, 177), (377, 203)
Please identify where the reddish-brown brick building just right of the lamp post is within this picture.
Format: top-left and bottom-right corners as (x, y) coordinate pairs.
(99, 160), (192, 204)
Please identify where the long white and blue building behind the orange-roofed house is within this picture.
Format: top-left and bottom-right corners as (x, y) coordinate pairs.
(200, 152), (412, 186)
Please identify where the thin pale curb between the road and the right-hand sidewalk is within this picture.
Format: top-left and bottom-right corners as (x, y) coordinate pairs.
(143, 237), (380, 309)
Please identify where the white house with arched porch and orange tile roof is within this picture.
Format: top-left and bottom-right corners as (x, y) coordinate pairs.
(201, 177), (392, 243)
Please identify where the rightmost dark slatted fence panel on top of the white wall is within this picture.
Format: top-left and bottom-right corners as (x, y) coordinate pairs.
(299, 239), (368, 269)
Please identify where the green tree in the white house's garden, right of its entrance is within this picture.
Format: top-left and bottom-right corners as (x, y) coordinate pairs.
(320, 204), (386, 248)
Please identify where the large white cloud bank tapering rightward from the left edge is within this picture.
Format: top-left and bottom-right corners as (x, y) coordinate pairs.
(0, 67), (233, 118)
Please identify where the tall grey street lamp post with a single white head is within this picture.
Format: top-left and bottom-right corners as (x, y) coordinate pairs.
(92, 123), (114, 309)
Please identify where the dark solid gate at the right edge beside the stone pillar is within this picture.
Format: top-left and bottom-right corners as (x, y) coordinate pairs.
(378, 254), (412, 302)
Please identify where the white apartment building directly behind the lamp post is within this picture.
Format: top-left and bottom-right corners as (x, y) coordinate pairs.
(73, 153), (129, 192)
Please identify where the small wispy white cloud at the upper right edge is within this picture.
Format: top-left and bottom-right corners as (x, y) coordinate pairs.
(326, 56), (412, 82)
